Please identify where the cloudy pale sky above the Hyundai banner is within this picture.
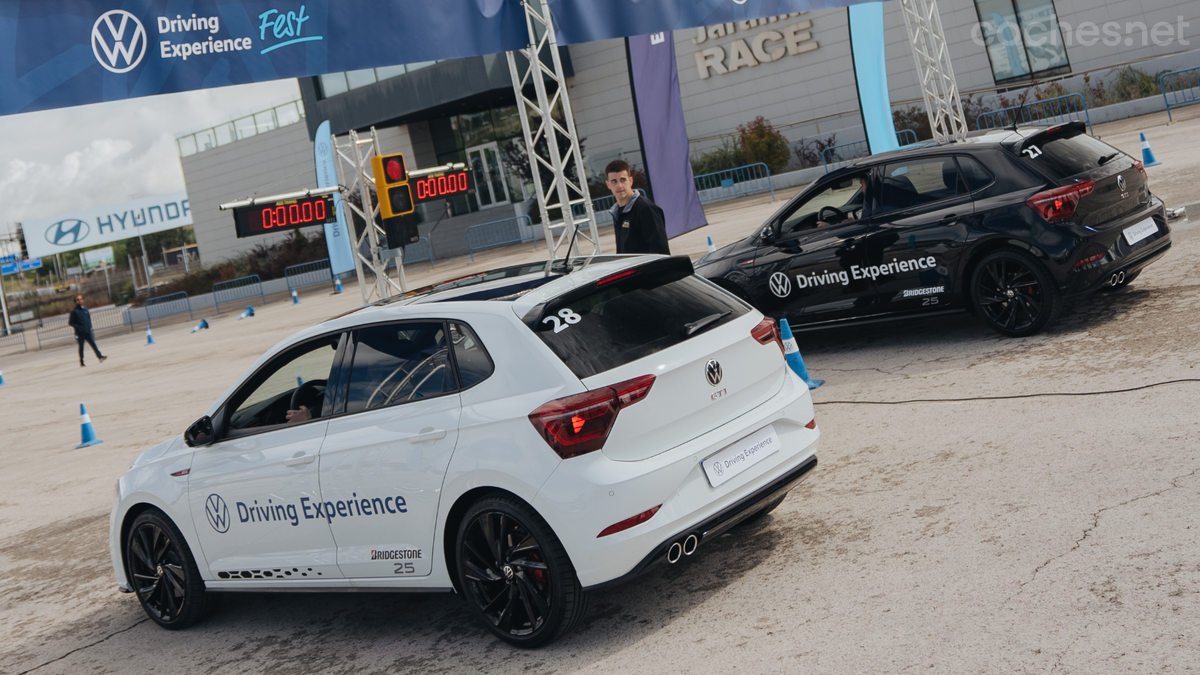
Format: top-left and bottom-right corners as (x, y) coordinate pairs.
(0, 79), (300, 251)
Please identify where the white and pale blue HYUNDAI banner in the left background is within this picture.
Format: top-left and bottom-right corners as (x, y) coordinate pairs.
(22, 192), (192, 258)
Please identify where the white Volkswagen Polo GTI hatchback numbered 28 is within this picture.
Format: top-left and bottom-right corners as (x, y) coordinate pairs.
(110, 256), (820, 646)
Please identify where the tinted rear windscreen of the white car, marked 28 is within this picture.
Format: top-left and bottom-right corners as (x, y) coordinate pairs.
(530, 259), (750, 378)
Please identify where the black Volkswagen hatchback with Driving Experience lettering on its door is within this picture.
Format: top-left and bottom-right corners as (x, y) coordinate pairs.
(695, 123), (1171, 336)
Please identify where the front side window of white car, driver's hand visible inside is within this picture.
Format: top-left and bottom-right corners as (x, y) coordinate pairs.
(229, 335), (341, 429)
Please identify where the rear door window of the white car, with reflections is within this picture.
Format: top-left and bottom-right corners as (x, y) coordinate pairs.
(346, 322), (455, 413)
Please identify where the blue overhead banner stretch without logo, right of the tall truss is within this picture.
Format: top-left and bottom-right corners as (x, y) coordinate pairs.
(544, 0), (870, 44)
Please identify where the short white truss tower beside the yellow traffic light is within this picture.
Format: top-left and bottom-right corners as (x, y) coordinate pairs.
(330, 126), (408, 303)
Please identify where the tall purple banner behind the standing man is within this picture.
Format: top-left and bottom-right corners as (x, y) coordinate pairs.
(629, 32), (708, 238)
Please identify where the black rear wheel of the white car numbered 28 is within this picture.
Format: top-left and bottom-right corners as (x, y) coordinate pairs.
(457, 496), (587, 647)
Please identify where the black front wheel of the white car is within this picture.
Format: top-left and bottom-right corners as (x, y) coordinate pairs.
(125, 509), (217, 631)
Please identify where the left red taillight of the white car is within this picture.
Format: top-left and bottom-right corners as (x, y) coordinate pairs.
(529, 375), (654, 459)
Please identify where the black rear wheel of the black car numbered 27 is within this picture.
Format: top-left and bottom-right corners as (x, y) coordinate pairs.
(971, 249), (1062, 338)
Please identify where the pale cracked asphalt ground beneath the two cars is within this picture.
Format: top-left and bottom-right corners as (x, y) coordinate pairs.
(7, 107), (1200, 675)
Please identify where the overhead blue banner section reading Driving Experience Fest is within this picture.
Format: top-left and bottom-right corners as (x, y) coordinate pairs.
(0, 0), (528, 114)
